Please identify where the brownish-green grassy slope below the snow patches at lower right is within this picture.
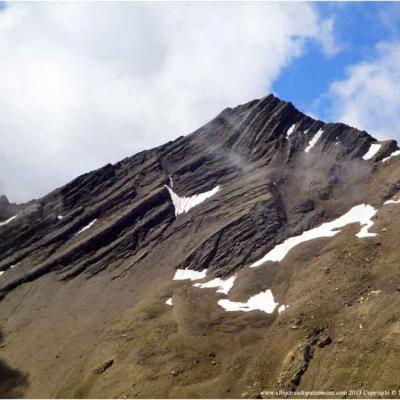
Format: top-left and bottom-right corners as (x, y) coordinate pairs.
(53, 205), (400, 398)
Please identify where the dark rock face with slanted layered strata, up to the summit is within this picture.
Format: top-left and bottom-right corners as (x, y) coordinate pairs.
(0, 95), (393, 294)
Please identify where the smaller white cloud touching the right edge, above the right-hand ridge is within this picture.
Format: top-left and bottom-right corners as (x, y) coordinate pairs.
(328, 42), (400, 139)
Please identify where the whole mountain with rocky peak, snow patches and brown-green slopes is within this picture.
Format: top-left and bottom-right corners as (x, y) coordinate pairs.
(0, 95), (400, 398)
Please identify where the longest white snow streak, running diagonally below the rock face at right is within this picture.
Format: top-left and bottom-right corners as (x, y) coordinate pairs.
(250, 204), (378, 267)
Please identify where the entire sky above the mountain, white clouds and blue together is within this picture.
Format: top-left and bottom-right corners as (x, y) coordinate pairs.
(0, 1), (400, 201)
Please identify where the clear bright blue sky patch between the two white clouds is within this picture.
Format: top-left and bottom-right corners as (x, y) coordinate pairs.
(273, 2), (400, 120)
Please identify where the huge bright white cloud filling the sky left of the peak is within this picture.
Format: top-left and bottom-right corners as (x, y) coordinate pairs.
(0, 3), (335, 200)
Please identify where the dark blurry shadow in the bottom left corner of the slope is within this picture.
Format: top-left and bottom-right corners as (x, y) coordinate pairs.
(0, 330), (28, 399)
